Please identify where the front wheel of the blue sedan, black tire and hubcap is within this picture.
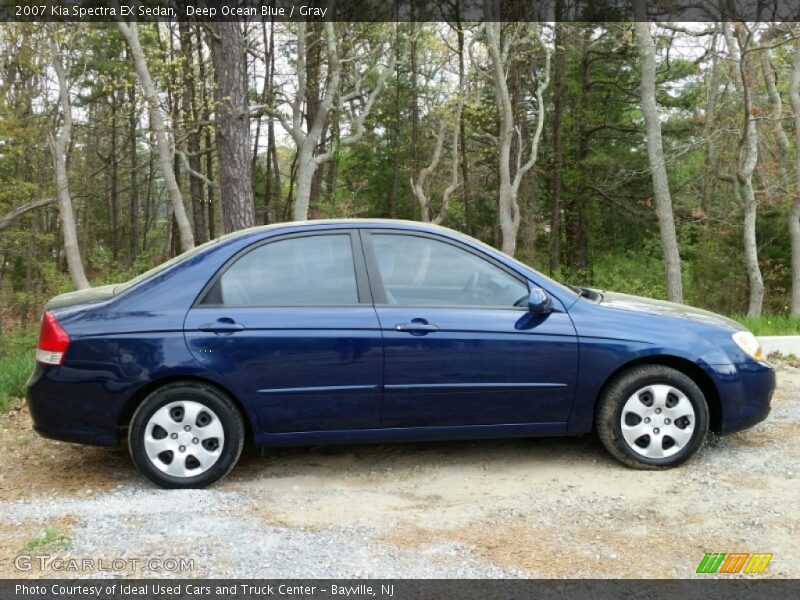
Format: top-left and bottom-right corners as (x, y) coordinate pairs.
(595, 365), (709, 470)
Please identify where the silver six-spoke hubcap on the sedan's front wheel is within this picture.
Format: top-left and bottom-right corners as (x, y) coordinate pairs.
(620, 384), (695, 458)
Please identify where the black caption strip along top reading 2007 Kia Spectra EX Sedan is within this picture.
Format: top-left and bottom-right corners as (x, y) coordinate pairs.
(0, 0), (800, 22)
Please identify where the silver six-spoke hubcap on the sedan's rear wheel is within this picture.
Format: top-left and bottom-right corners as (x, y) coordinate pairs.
(144, 400), (225, 477)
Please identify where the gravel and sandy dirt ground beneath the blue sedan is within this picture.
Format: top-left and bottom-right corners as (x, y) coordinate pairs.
(0, 362), (800, 578)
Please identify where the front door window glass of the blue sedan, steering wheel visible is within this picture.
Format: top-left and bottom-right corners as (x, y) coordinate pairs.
(371, 233), (528, 307)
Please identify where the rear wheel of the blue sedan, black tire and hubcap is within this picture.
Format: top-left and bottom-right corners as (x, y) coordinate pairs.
(128, 382), (245, 489)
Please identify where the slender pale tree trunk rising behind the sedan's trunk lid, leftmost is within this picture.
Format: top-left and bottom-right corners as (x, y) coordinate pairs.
(49, 39), (91, 290)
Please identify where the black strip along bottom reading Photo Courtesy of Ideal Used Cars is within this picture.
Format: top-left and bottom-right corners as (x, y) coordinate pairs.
(0, 579), (800, 600)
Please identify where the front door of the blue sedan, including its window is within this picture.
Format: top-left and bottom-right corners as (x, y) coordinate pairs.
(363, 230), (578, 429)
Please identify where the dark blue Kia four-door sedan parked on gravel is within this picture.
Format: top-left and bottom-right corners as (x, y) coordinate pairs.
(27, 220), (775, 488)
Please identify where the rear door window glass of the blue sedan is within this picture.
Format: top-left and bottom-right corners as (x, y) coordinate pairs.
(208, 234), (358, 306)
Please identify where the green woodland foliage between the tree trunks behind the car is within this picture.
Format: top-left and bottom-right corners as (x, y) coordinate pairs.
(0, 19), (793, 328)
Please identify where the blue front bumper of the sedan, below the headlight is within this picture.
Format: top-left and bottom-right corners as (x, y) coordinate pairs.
(713, 361), (775, 434)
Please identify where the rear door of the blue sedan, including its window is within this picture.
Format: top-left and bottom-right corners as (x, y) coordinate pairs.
(184, 230), (383, 433)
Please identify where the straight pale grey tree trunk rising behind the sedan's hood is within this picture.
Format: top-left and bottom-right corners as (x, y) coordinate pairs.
(634, 11), (683, 303)
